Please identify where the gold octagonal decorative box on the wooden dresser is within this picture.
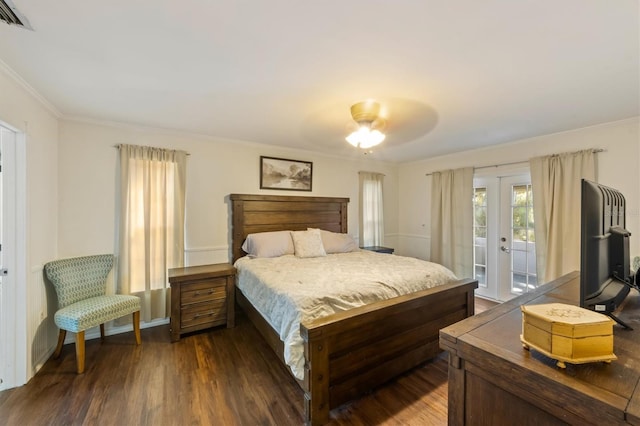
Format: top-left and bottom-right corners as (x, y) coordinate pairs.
(520, 303), (617, 368)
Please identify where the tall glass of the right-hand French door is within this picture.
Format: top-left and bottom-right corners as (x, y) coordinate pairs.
(511, 185), (538, 294)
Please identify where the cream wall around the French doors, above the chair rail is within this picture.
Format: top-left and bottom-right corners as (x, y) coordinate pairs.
(397, 117), (640, 259)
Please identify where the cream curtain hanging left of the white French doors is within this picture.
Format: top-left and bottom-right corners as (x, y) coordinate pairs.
(431, 167), (473, 278)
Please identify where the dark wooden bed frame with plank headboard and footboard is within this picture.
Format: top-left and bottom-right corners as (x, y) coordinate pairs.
(229, 194), (478, 425)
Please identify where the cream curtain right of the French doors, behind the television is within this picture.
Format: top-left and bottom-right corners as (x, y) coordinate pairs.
(529, 149), (596, 283)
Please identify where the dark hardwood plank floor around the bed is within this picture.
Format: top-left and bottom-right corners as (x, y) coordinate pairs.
(0, 298), (495, 425)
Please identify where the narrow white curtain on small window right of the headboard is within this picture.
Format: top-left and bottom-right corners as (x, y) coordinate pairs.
(359, 172), (384, 247)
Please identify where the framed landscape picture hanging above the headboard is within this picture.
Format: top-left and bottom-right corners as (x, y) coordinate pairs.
(260, 156), (313, 191)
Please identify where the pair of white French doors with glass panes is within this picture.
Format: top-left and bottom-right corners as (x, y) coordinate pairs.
(474, 174), (538, 301)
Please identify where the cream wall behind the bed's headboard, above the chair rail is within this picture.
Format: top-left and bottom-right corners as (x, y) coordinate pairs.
(58, 121), (398, 265)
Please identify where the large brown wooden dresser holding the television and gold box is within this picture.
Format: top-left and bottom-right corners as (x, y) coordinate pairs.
(440, 272), (640, 425)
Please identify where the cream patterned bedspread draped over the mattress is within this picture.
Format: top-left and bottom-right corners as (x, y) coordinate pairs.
(235, 250), (457, 380)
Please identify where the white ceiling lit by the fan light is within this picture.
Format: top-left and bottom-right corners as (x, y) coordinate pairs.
(0, 0), (640, 162)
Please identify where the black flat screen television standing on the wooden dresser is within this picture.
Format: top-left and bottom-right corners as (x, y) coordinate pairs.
(580, 179), (632, 328)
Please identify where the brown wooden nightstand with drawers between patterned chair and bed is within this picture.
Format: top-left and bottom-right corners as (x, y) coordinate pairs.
(169, 263), (236, 342)
